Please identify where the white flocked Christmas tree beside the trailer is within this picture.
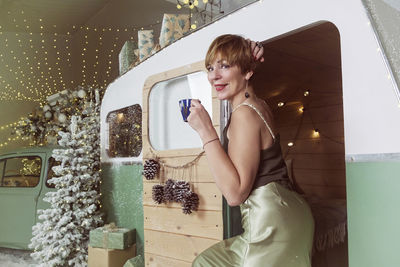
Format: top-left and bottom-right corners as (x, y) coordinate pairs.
(30, 92), (103, 267)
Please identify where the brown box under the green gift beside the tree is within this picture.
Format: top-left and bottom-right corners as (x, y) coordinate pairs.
(88, 244), (136, 267)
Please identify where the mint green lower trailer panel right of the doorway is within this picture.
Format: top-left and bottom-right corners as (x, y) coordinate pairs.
(346, 162), (400, 267)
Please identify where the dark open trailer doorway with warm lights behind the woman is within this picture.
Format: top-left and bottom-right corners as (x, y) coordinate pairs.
(254, 21), (348, 267)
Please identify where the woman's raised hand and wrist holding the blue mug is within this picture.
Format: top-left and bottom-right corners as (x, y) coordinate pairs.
(187, 99), (218, 142)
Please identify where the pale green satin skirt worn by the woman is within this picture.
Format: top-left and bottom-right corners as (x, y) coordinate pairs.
(192, 182), (314, 267)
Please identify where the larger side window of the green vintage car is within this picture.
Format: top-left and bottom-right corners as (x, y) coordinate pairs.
(0, 156), (42, 187)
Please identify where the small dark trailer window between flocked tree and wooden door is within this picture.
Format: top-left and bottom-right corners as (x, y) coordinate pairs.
(106, 104), (142, 158)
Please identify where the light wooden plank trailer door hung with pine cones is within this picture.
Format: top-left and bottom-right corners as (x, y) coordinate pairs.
(142, 61), (223, 267)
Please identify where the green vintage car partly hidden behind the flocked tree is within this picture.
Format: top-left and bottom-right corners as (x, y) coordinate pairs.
(0, 147), (56, 249)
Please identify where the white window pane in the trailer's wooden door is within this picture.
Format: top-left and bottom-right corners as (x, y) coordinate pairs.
(148, 71), (212, 150)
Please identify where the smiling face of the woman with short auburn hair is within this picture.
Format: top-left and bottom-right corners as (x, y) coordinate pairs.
(207, 57), (247, 100)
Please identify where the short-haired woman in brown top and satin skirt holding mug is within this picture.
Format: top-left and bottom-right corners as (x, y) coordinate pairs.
(188, 34), (314, 267)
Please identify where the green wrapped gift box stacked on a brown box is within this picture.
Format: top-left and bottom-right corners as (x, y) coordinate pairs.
(89, 225), (136, 249)
